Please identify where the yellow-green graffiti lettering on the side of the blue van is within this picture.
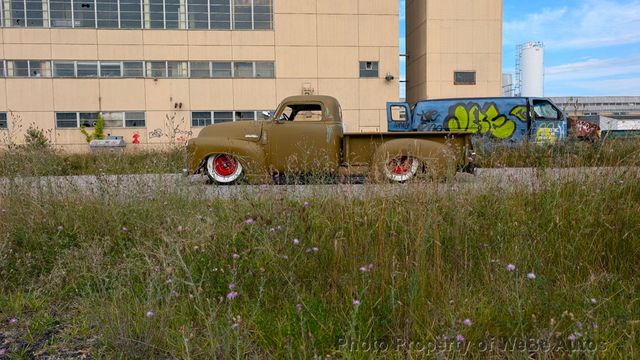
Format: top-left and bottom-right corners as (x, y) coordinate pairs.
(443, 102), (526, 139)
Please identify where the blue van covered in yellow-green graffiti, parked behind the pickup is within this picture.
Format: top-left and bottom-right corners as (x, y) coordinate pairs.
(387, 97), (567, 142)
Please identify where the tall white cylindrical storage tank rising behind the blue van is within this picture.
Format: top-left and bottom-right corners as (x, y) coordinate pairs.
(519, 41), (544, 97)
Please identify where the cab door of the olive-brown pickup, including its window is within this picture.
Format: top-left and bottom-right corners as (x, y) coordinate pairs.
(264, 103), (342, 173)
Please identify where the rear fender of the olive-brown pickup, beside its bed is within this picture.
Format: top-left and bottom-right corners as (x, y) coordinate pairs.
(371, 138), (457, 179)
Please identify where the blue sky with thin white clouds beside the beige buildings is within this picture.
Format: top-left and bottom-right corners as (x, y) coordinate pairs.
(400, 0), (640, 96)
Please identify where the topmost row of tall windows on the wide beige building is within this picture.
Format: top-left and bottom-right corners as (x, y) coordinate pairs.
(0, 0), (273, 30)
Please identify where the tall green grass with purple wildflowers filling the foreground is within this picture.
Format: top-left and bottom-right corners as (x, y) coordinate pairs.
(0, 169), (640, 359)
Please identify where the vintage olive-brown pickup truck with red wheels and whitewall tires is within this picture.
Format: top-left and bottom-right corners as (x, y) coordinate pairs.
(185, 96), (475, 184)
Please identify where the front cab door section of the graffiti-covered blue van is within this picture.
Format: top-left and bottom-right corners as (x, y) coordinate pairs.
(531, 99), (567, 143)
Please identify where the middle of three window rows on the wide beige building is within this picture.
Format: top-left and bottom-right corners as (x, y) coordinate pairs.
(0, 60), (275, 78)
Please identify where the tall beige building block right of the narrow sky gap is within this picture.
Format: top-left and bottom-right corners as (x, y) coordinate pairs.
(406, 0), (502, 103)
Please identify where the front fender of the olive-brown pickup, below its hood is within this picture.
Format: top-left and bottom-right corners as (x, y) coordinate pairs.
(196, 139), (268, 182)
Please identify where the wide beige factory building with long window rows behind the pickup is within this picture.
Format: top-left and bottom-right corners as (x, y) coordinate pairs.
(0, 0), (399, 151)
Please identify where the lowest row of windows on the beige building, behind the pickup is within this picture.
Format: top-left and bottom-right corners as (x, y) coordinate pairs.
(49, 110), (264, 129)
